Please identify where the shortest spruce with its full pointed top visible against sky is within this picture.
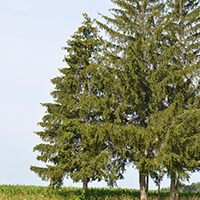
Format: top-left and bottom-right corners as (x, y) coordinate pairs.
(30, 14), (117, 193)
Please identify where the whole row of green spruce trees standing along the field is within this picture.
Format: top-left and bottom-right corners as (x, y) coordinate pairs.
(31, 0), (200, 199)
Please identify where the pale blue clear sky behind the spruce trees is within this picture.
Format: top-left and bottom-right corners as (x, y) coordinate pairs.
(0, 0), (200, 189)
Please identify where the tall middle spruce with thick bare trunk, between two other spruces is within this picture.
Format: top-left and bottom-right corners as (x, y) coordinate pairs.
(98, 0), (164, 199)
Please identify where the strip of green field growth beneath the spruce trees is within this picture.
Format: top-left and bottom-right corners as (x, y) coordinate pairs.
(0, 185), (200, 200)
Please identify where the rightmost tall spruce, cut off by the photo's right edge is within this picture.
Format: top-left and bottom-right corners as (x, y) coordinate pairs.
(157, 0), (200, 199)
